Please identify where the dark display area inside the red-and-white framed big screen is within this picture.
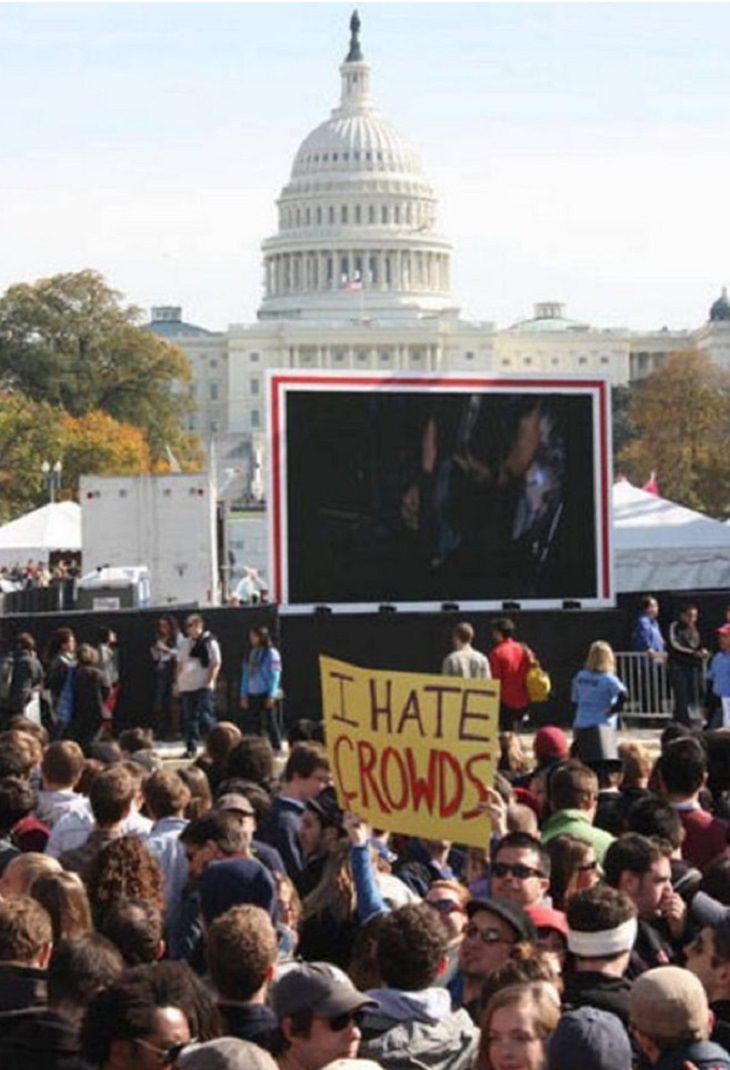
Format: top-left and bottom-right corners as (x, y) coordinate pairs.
(286, 387), (597, 605)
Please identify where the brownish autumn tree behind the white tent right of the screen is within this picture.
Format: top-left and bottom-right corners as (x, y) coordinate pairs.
(619, 350), (730, 516)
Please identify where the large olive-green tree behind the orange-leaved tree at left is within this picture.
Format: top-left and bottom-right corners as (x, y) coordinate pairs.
(0, 271), (200, 467)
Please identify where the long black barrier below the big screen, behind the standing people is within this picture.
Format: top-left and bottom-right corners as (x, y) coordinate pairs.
(0, 591), (730, 727)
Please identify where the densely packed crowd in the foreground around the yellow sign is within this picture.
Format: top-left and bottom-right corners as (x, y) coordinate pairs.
(0, 692), (730, 1070)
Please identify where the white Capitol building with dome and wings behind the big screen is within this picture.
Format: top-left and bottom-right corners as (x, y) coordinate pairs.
(150, 13), (730, 468)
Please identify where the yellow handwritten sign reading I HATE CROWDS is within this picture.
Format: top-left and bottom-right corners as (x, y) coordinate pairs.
(319, 657), (499, 847)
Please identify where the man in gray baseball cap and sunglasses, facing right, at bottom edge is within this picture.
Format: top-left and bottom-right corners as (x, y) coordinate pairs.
(271, 962), (375, 1070)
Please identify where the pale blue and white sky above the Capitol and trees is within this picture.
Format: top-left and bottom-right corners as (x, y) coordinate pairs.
(0, 3), (730, 327)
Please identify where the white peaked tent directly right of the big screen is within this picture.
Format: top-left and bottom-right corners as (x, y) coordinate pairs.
(613, 479), (730, 593)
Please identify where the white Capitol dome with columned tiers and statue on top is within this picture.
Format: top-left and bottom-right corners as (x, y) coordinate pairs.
(258, 12), (458, 321)
